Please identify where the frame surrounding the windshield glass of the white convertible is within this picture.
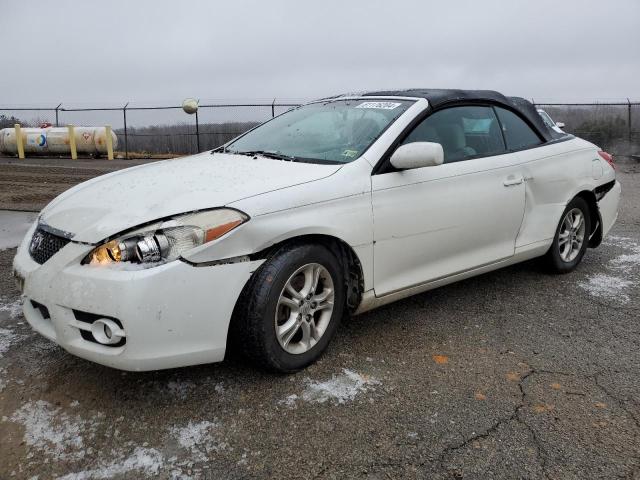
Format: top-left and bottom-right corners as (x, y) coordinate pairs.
(218, 95), (419, 165)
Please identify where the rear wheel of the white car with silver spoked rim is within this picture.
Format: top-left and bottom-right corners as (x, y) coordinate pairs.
(546, 197), (591, 273)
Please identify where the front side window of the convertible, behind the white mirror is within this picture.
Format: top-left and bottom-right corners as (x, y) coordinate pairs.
(402, 106), (506, 163)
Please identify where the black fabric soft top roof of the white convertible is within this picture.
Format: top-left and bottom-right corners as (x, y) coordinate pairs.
(362, 88), (563, 141)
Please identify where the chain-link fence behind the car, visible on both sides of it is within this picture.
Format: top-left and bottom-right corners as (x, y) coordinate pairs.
(0, 100), (640, 158)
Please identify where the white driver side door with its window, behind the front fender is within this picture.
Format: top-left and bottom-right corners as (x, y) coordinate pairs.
(372, 106), (525, 296)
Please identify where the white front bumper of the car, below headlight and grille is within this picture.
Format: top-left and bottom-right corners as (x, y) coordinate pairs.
(14, 228), (262, 371)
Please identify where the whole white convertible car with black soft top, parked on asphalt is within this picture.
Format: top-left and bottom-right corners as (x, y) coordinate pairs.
(14, 89), (620, 372)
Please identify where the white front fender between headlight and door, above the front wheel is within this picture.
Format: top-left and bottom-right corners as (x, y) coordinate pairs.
(183, 162), (373, 285)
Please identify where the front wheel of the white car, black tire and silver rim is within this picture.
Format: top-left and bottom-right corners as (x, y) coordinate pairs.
(230, 244), (345, 373)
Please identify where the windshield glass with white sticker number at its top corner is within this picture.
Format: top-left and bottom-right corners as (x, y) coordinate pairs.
(225, 99), (413, 163)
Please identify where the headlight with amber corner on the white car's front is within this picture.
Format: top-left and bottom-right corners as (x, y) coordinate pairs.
(82, 208), (249, 266)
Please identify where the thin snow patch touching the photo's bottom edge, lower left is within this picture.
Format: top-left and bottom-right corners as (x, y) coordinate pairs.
(58, 447), (164, 480)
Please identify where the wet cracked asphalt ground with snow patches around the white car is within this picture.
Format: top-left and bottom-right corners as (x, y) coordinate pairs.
(0, 158), (640, 480)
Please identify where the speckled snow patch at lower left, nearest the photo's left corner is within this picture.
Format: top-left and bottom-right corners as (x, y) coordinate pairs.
(11, 400), (97, 460)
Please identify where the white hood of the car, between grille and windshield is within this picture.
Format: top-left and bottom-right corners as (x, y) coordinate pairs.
(41, 152), (341, 243)
